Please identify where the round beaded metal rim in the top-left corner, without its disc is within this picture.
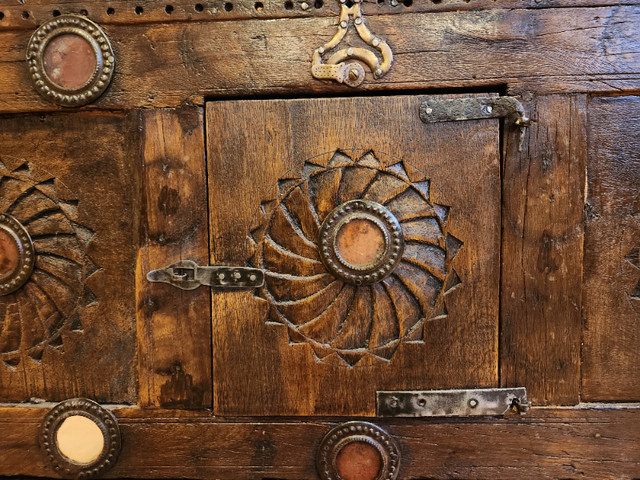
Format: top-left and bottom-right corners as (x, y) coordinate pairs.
(27, 15), (115, 107)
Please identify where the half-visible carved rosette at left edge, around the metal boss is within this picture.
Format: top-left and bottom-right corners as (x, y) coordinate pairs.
(0, 159), (99, 368)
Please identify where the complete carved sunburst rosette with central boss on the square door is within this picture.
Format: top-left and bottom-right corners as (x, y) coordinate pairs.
(251, 151), (462, 366)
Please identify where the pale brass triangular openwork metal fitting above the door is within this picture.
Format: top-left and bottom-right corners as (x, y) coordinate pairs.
(311, 0), (393, 87)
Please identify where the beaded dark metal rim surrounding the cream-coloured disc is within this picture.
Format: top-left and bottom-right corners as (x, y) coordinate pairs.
(40, 398), (121, 478)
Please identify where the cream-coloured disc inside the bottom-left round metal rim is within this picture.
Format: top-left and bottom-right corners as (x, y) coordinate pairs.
(56, 415), (104, 464)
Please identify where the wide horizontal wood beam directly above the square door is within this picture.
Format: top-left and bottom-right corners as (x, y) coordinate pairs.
(0, 5), (640, 112)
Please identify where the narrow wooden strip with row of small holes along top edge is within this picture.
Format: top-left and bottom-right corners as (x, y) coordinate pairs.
(0, 0), (638, 31)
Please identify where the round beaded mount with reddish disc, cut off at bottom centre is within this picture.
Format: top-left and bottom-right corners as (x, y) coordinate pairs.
(316, 421), (400, 480)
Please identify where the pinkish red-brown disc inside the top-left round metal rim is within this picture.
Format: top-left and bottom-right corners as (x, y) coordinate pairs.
(43, 33), (98, 89)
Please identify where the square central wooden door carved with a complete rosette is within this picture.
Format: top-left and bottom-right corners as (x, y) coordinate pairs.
(207, 97), (500, 415)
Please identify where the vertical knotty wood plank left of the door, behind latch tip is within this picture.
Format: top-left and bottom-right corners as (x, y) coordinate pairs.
(136, 107), (211, 408)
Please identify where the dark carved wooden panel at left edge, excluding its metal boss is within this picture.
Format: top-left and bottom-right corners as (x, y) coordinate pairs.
(0, 112), (137, 402)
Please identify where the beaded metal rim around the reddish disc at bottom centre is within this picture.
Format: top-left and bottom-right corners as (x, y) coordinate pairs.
(316, 421), (400, 480)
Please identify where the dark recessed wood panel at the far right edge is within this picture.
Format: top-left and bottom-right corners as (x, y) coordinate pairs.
(582, 97), (640, 401)
